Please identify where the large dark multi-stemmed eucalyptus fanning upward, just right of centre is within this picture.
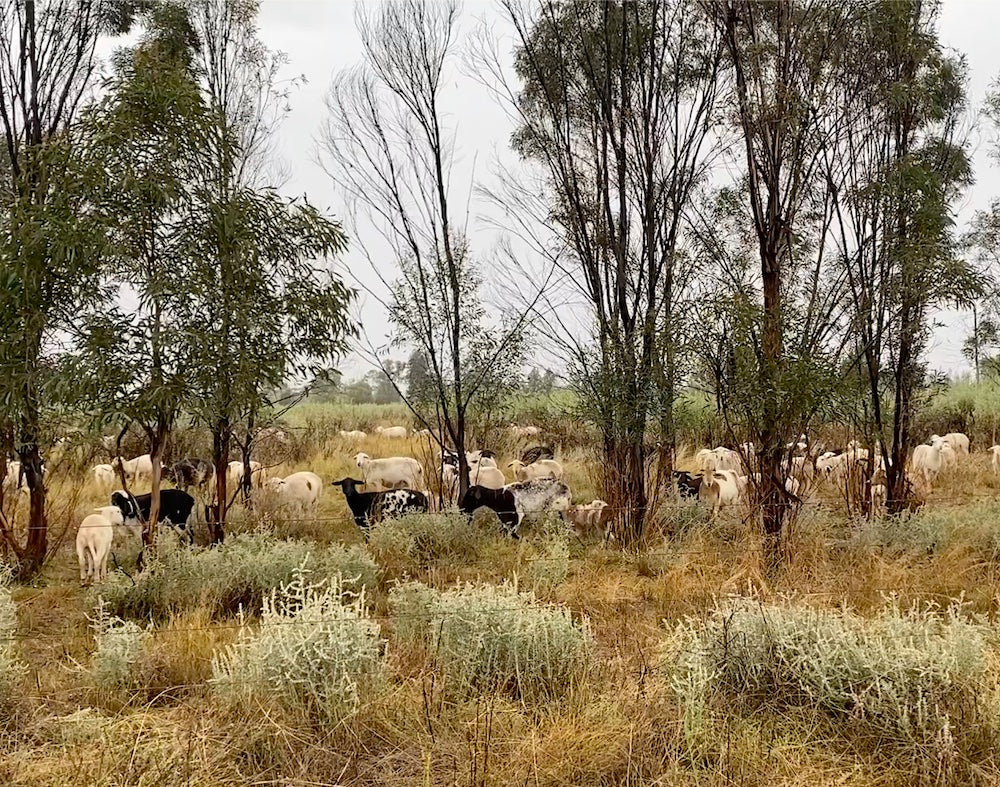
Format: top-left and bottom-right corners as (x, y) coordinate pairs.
(479, 0), (724, 543)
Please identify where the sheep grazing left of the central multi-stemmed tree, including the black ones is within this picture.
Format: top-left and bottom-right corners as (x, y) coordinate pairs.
(68, 427), (610, 582)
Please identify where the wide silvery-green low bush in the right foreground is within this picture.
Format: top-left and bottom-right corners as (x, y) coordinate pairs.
(665, 601), (997, 758)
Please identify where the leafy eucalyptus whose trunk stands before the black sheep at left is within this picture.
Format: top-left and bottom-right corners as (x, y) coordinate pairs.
(82, 2), (209, 543)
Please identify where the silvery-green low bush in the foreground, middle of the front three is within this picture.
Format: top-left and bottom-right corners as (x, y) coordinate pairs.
(390, 582), (594, 704)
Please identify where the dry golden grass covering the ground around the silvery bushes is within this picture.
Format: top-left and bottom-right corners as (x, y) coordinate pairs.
(0, 428), (1000, 787)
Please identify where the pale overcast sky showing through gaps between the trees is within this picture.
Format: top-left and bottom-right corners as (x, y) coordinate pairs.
(248, 0), (1000, 382)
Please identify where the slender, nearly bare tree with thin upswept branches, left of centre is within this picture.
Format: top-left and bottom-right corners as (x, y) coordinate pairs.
(322, 0), (526, 494)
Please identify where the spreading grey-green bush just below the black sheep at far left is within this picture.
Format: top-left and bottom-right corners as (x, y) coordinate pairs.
(100, 533), (378, 621)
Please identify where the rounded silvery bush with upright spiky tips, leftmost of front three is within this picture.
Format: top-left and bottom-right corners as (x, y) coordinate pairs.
(211, 572), (385, 723)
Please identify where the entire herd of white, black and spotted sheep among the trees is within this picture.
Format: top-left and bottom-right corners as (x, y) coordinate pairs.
(3, 426), (988, 581)
